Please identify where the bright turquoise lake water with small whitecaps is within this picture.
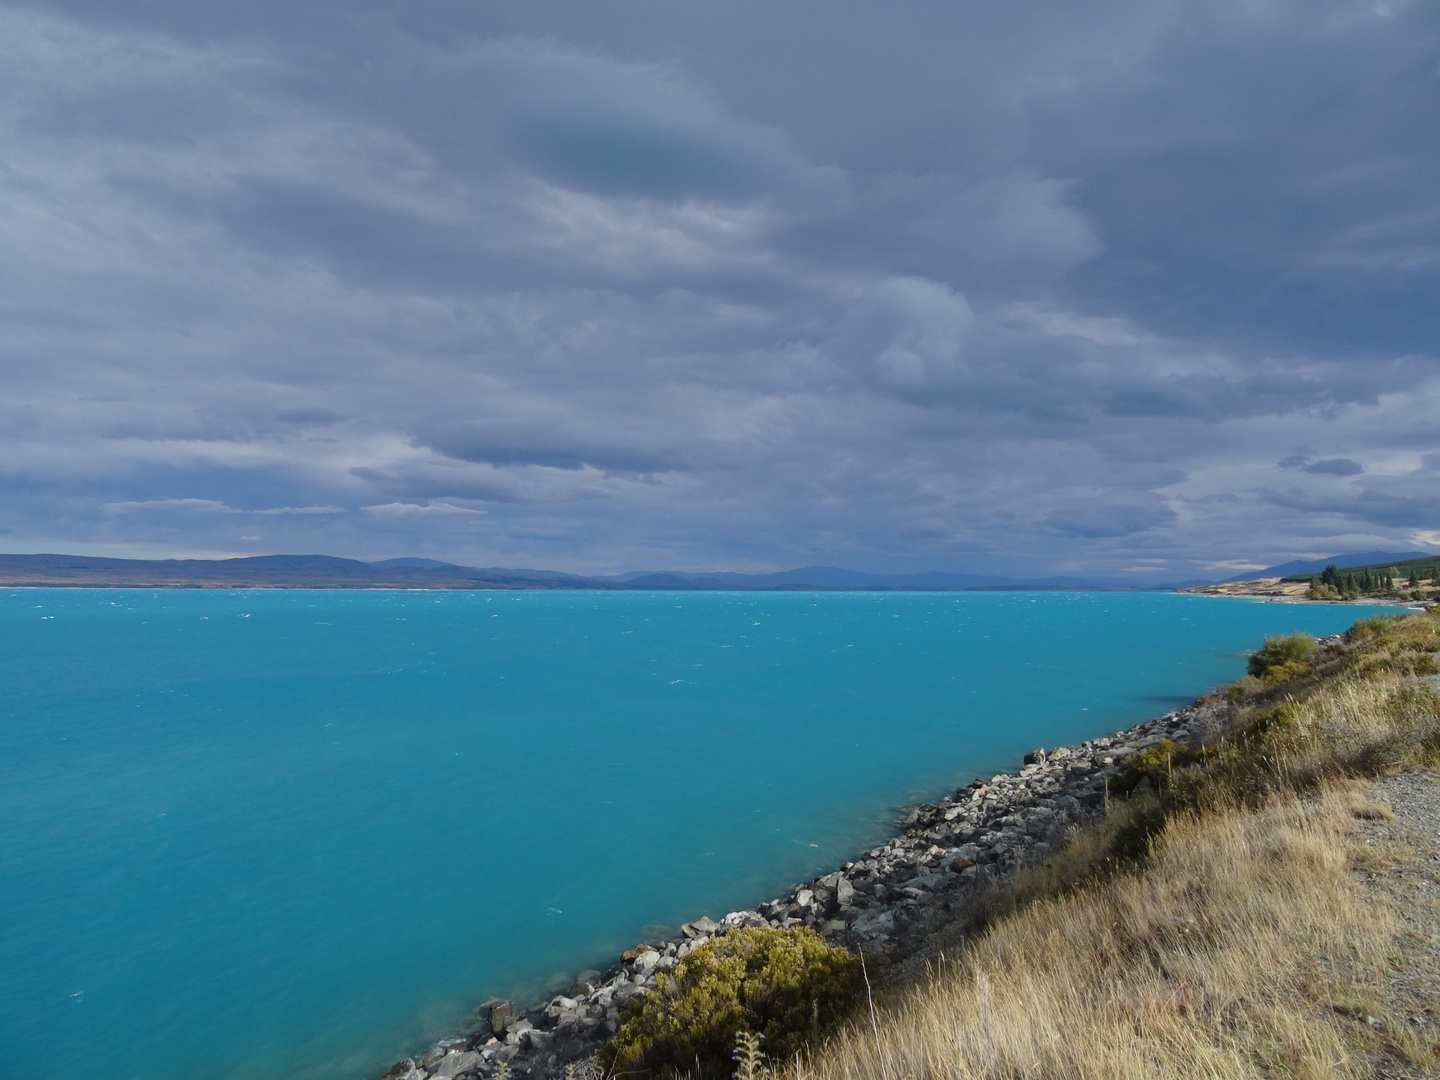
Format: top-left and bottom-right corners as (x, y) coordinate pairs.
(0, 590), (1393, 1080)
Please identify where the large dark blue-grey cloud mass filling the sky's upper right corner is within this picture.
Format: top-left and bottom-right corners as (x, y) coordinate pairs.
(1034, 3), (1440, 356)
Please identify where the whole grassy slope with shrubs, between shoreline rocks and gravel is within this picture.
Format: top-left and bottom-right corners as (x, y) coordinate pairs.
(800, 613), (1440, 1080)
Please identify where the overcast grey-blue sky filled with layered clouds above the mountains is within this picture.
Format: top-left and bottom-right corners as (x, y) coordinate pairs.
(0, 0), (1440, 577)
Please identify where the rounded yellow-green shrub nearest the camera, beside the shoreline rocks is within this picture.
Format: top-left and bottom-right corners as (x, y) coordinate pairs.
(600, 927), (861, 1077)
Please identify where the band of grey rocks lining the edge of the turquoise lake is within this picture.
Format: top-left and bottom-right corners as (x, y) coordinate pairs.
(382, 650), (1284, 1080)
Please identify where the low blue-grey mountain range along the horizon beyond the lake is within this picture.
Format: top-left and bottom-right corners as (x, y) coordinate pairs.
(0, 552), (1433, 592)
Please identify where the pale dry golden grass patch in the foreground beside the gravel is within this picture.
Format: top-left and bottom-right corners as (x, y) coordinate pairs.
(804, 793), (1395, 1080)
